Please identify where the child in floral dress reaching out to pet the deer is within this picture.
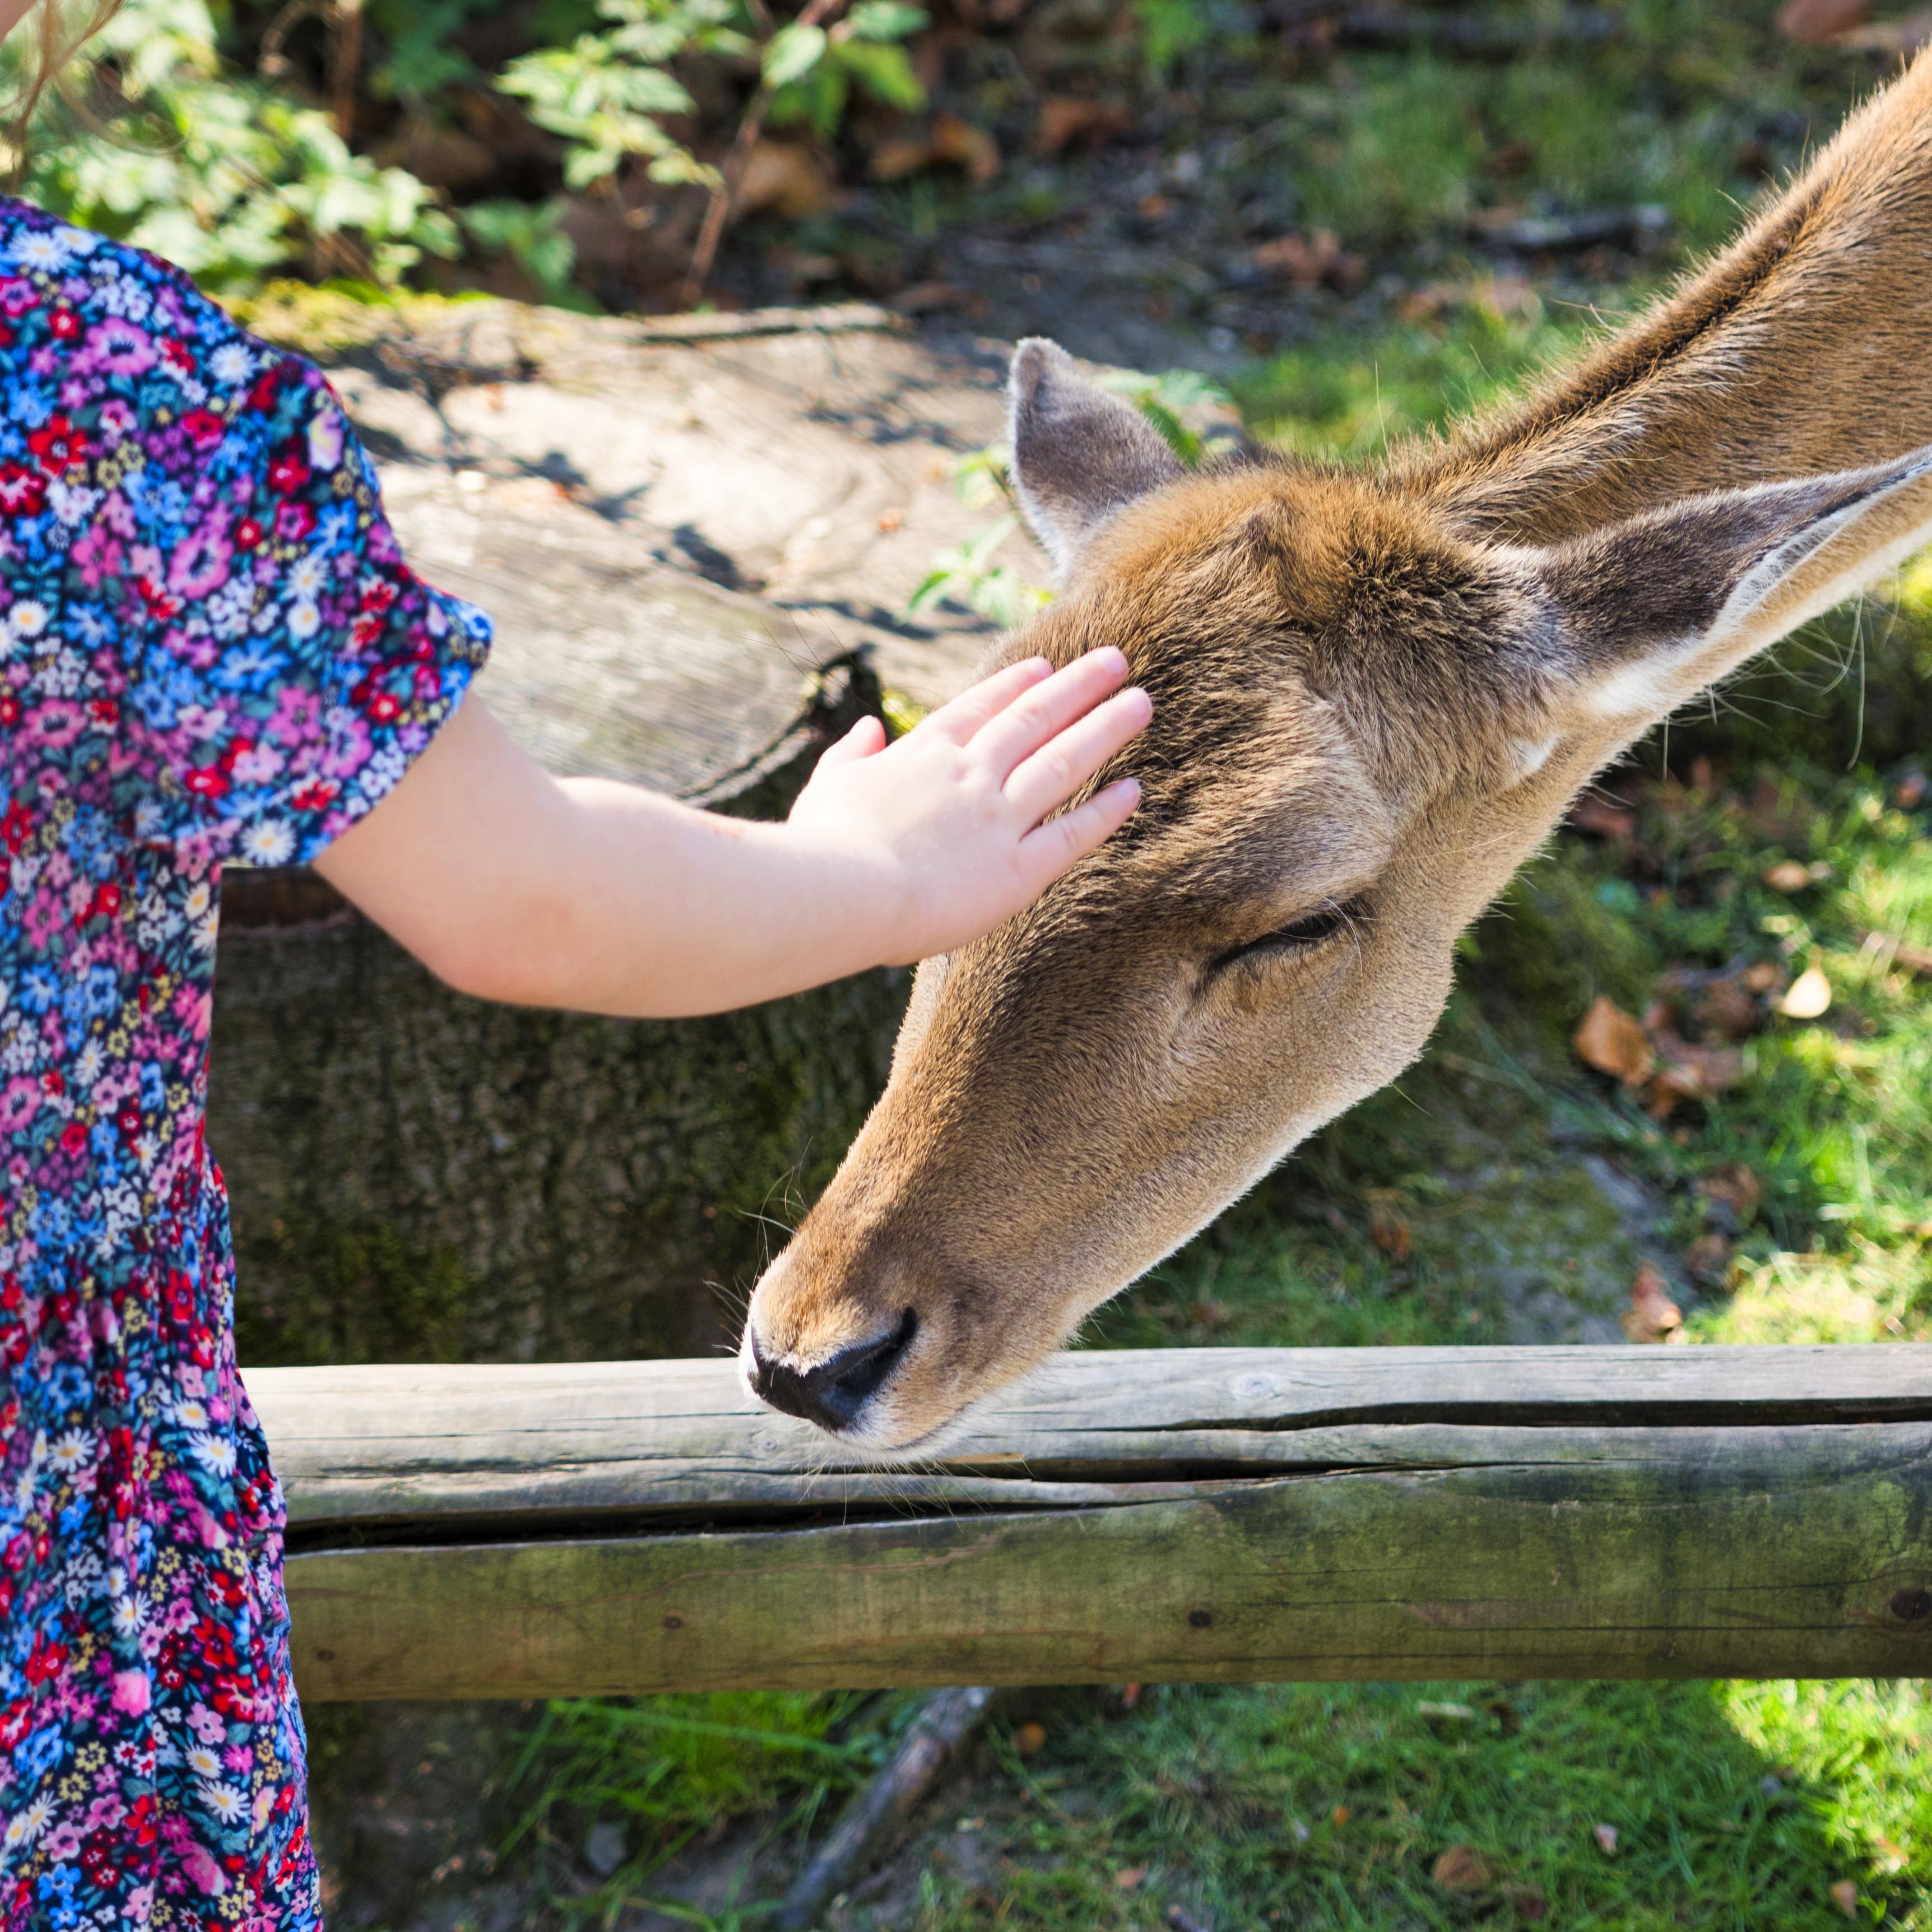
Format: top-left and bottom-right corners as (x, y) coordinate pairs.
(0, 0), (1148, 1932)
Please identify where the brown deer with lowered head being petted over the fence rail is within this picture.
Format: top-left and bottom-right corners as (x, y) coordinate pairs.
(740, 54), (1932, 1457)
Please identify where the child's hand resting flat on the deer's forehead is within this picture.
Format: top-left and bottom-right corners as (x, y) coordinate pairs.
(786, 645), (1151, 964)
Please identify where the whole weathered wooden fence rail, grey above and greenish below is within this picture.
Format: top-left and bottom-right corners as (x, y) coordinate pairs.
(247, 1345), (1932, 1700)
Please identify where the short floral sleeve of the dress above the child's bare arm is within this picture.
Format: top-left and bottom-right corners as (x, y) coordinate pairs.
(122, 350), (491, 866)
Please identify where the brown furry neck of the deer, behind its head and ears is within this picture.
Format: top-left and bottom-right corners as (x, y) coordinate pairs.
(1395, 52), (1932, 543)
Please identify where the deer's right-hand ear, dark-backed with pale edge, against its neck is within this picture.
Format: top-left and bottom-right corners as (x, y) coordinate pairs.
(1532, 446), (1932, 719)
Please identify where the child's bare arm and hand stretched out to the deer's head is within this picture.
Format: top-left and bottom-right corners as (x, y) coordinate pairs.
(315, 649), (1150, 1018)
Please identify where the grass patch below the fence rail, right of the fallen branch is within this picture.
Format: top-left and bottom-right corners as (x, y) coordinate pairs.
(916, 1683), (1932, 1932)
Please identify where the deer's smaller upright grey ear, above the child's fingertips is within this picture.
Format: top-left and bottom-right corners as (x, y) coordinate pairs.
(1009, 336), (1182, 582)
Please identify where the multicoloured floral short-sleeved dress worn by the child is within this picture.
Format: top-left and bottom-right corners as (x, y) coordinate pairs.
(0, 201), (489, 1932)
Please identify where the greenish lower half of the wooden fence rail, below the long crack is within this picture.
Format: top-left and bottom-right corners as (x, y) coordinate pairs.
(288, 1424), (1932, 1698)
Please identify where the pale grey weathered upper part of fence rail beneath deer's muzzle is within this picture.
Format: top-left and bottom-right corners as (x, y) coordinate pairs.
(249, 1346), (1932, 1542)
